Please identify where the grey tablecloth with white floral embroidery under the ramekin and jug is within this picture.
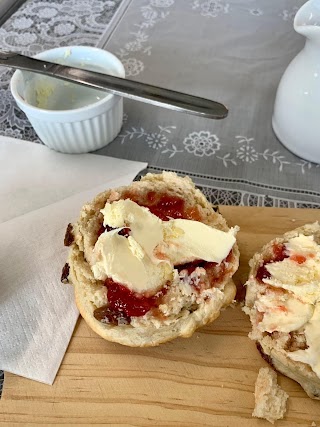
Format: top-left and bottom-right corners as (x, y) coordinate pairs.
(0, 0), (320, 422)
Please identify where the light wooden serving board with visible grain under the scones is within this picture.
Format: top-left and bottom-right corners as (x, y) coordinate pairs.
(0, 206), (320, 427)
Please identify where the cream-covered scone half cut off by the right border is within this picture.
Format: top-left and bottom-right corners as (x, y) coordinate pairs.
(244, 222), (320, 399)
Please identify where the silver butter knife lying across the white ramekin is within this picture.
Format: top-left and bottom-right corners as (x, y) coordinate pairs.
(0, 51), (228, 119)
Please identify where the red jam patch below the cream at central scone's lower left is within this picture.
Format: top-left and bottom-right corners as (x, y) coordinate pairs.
(94, 279), (167, 324)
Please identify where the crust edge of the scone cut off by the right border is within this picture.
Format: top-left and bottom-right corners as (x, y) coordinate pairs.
(245, 222), (320, 400)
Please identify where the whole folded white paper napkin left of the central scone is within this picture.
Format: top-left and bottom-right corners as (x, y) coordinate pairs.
(0, 138), (146, 384)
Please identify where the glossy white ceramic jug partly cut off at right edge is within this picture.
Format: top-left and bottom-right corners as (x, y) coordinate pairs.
(272, 0), (320, 163)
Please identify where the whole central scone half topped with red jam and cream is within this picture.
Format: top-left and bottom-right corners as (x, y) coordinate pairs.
(63, 172), (239, 347)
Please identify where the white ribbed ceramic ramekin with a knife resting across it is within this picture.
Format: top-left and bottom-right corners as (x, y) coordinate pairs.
(10, 46), (125, 153)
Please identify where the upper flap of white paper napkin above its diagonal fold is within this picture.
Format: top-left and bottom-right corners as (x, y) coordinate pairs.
(0, 137), (146, 223)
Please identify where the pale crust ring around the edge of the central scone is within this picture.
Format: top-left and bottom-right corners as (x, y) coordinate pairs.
(68, 172), (239, 347)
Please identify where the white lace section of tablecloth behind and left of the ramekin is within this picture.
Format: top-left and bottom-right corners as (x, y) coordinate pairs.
(0, 0), (121, 142)
